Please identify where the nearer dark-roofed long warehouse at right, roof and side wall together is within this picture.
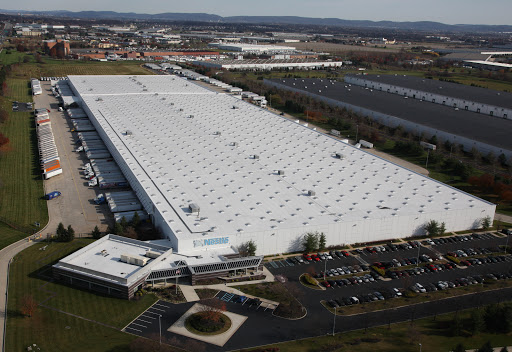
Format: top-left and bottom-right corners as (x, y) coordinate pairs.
(265, 76), (512, 158)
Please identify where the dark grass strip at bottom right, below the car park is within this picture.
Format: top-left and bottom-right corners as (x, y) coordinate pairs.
(252, 304), (512, 352)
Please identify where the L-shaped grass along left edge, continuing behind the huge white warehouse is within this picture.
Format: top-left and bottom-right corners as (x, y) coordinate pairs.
(0, 50), (155, 249)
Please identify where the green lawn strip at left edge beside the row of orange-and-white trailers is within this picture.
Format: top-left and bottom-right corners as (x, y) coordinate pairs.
(0, 79), (48, 247)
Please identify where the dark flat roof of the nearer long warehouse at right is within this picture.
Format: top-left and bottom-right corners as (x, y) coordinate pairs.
(271, 76), (512, 150)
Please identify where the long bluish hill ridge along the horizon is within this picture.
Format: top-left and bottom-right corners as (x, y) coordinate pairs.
(0, 10), (512, 32)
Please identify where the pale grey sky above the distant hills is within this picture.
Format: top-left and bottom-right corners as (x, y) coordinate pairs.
(4, 0), (512, 25)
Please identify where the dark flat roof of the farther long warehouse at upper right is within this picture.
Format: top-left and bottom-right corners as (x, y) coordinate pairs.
(349, 75), (512, 109)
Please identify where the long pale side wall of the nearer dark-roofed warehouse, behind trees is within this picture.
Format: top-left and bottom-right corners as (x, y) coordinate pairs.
(264, 80), (512, 159)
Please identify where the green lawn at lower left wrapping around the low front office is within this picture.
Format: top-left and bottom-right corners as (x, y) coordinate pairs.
(6, 239), (156, 351)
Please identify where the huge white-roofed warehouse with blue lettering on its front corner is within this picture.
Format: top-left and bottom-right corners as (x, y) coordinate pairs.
(69, 76), (495, 255)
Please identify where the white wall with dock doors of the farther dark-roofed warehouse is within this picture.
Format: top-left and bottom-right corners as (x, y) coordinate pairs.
(344, 76), (512, 119)
